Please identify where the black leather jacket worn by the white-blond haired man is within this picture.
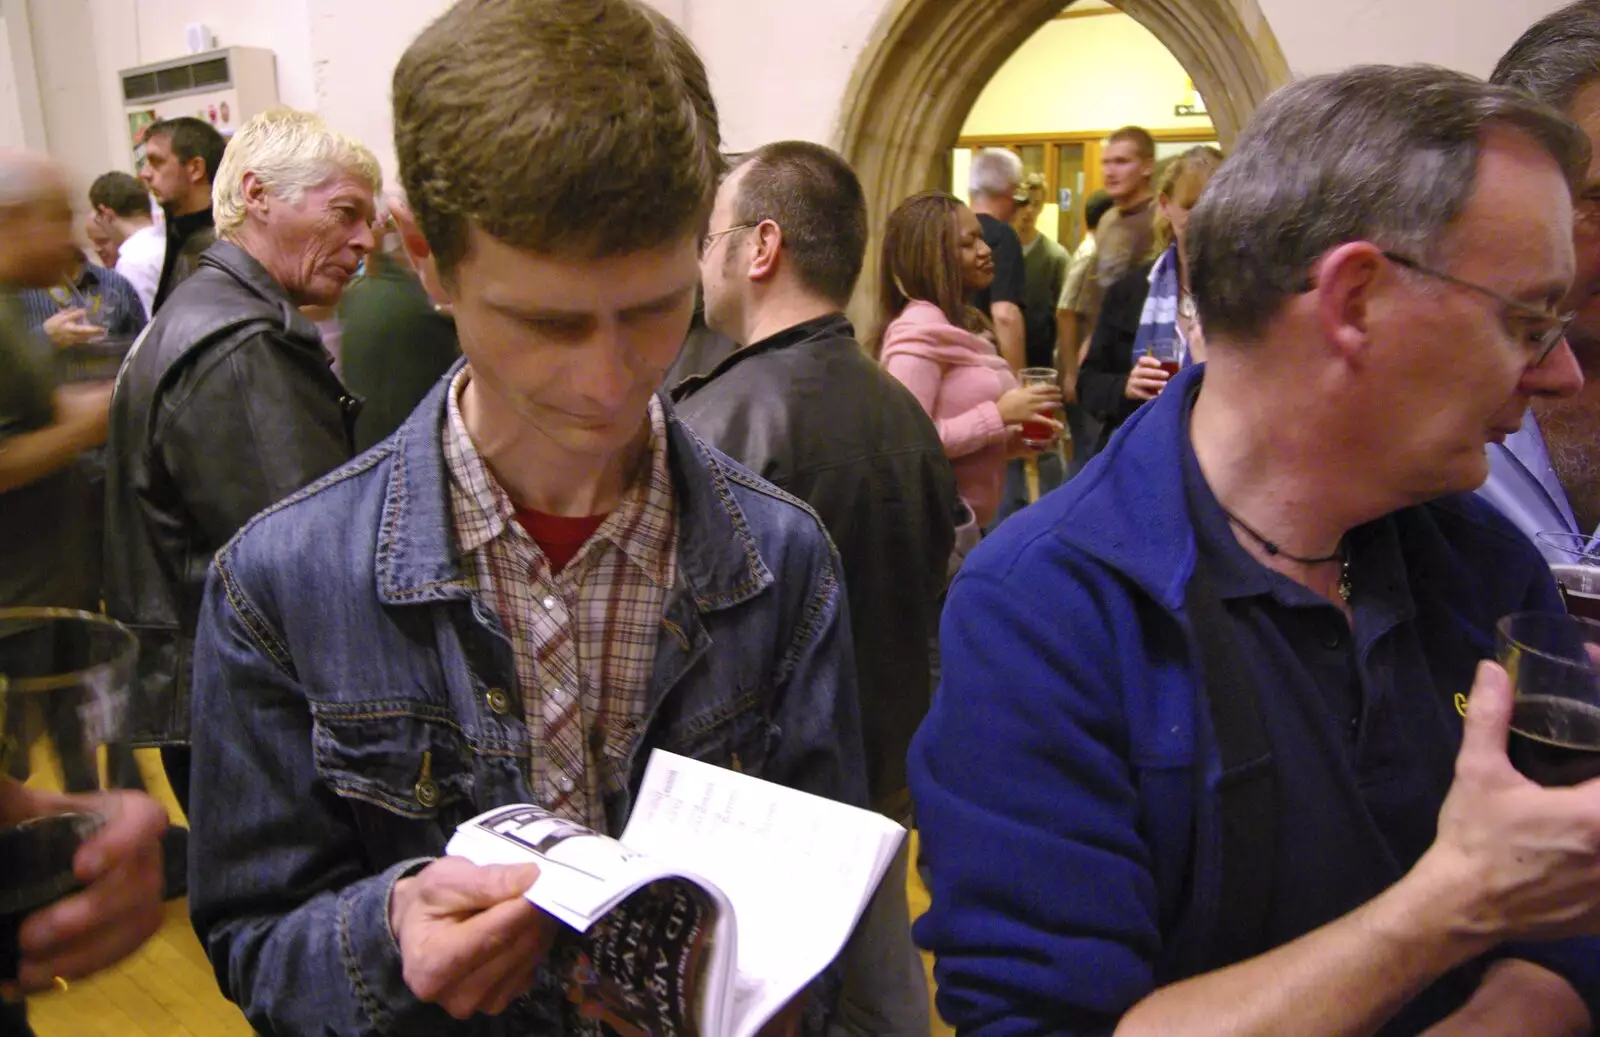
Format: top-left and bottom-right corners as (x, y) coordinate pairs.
(106, 242), (358, 744)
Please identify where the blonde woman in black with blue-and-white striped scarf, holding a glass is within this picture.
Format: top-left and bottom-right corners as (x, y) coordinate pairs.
(1078, 147), (1222, 453)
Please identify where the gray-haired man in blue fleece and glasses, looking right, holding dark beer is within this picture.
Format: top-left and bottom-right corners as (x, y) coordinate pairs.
(910, 67), (1600, 1037)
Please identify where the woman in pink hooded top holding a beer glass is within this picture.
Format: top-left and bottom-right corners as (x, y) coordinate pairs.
(874, 190), (1061, 527)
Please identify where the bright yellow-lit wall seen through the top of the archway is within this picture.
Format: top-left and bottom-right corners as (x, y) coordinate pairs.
(962, 13), (1211, 136)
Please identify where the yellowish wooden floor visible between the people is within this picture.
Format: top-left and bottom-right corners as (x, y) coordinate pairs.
(29, 751), (955, 1037)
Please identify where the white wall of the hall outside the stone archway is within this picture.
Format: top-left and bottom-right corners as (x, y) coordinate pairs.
(18, 0), (1593, 190)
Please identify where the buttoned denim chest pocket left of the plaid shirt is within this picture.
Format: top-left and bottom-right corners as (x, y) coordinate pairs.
(312, 699), (472, 821)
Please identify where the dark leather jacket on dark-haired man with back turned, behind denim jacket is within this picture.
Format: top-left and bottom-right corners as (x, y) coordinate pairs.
(672, 314), (957, 818)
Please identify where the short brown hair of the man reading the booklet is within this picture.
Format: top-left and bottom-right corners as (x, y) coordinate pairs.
(394, 0), (723, 277)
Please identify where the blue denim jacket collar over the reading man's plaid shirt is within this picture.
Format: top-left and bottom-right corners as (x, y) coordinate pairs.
(376, 360), (773, 613)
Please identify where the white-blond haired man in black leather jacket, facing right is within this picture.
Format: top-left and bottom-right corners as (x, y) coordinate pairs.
(106, 109), (382, 819)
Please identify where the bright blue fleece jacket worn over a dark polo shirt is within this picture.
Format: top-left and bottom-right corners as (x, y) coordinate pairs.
(910, 366), (1600, 1037)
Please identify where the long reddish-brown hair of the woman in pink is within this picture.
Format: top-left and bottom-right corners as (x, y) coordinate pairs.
(870, 190), (971, 357)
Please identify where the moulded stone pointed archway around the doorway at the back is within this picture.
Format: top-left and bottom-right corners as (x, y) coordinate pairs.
(838, 0), (1290, 323)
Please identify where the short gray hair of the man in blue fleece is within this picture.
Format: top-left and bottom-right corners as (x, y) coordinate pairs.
(1186, 66), (1589, 339)
